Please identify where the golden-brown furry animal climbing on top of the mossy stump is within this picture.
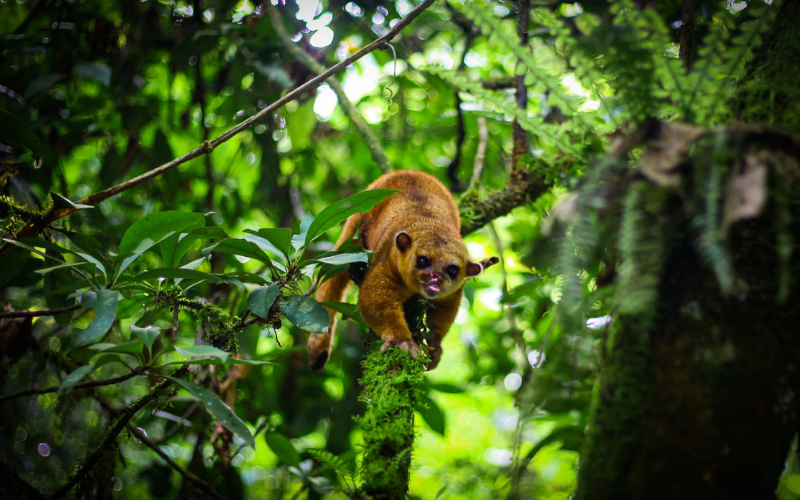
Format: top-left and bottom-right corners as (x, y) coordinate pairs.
(307, 170), (497, 370)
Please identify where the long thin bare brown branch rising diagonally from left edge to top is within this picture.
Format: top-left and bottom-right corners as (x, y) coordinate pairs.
(0, 0), (436, 250)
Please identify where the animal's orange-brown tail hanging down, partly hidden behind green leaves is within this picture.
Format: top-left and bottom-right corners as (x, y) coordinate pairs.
(306, 214), (364, 372)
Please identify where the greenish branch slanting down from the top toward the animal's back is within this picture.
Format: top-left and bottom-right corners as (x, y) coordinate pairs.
(267, 6), (392, 174)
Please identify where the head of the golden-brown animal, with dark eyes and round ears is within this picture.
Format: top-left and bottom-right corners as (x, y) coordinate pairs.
(395, 231), (499, 299)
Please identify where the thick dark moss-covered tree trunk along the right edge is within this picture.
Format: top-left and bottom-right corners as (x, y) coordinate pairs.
(576, 1), (800, 500)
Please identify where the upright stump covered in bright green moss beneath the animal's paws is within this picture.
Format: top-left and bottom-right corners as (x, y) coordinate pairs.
(356, 342), (425, 499)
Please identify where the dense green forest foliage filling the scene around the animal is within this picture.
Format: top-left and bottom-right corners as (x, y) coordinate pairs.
(0, 0), (800, 499)
